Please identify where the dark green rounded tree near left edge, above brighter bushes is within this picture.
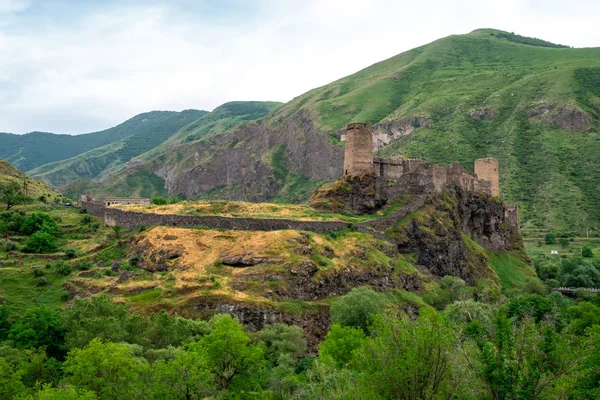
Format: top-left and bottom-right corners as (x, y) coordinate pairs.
(8, 306), (64, 359)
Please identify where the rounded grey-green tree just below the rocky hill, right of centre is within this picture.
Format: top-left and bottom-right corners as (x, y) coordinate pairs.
(330, 287), (386, 333)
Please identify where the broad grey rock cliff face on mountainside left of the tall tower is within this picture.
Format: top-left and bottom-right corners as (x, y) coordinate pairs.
(152, 111), (343, 201)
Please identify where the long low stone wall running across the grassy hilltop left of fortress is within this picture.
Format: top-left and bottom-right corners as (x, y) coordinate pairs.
(82, 202), (349, 233)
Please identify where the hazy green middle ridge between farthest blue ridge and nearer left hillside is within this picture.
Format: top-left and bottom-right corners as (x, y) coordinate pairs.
(30, 110), (207, 185)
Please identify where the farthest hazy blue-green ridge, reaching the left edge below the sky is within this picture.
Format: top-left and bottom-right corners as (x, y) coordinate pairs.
(0, 110), (206, 171)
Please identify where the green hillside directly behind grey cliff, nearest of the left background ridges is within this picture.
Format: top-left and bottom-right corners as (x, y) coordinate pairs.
(61, 101), (281, 198)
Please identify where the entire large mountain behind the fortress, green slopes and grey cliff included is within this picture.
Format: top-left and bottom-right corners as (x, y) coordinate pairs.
(96, 29), (600, 229)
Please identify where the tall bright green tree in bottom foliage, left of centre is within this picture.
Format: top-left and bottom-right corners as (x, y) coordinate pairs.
(189, 315), (265, 393)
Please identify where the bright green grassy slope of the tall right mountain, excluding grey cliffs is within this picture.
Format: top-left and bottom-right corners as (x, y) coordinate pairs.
(267, 30), (600, 228)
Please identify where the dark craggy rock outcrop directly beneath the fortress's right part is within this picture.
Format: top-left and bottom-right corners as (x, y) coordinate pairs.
(385, 188), (526, 284)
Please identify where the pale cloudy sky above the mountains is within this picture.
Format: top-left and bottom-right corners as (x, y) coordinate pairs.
(0, 0), (600, 134)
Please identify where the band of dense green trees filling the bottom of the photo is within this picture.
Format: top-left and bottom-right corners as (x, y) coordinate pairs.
(0, 293), (600, 400)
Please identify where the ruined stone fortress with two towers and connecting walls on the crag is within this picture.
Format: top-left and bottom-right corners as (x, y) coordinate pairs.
(344, 123), (518, 224)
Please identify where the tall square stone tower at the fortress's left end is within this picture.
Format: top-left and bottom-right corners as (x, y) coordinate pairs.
(344, 123), (373, 175)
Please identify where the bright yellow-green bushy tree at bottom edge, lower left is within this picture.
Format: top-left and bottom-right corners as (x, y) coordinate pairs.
(63, 339), (148, 400)
